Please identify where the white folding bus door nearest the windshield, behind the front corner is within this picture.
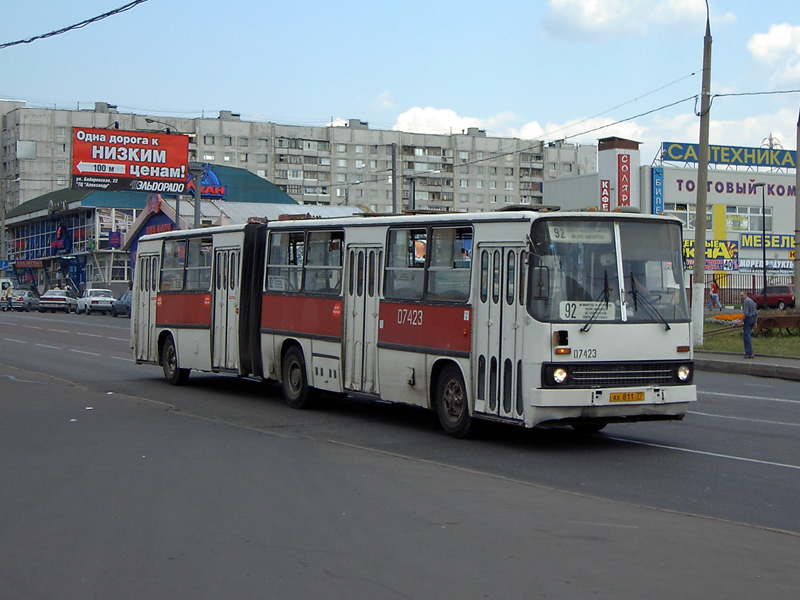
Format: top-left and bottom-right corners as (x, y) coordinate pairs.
(473, 245), (525, 420)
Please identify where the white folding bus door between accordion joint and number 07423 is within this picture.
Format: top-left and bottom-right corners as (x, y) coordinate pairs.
(344, 246), (382, 394)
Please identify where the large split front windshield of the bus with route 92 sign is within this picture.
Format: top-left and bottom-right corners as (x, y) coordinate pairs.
(528, 218), (689, 324)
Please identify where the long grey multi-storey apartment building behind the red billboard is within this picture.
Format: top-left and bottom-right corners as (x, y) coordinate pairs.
(0, 100), (597, 212)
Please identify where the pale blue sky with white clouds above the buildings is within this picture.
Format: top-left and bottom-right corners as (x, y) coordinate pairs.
(0, 0), (800, 164)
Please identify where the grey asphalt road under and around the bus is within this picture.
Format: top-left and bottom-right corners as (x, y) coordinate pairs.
(0, 313), (800, 600)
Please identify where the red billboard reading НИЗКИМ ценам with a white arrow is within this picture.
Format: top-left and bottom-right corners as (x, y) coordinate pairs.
(72, 127), (189, 194)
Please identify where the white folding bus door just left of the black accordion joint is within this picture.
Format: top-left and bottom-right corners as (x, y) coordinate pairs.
(211, 248), (239, 370)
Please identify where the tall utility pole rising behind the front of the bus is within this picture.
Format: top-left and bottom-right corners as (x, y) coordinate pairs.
(692, 7), (711, 347)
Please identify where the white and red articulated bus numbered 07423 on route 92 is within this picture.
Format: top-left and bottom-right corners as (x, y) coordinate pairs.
(131, 210), (696, 437)
